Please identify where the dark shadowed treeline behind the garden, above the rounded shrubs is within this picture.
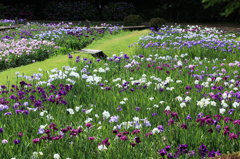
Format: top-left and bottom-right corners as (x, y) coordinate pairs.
(0, 0), (240, 23)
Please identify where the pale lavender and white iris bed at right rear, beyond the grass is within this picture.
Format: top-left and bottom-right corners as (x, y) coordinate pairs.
(139, 26), (240, 59)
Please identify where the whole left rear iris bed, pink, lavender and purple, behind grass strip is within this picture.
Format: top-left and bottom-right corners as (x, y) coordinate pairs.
(0, 23), (121, 71)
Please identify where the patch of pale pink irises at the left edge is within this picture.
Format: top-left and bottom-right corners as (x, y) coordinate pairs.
(0, 39), (58, 71)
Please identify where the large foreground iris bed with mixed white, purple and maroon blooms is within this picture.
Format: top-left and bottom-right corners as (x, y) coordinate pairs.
(0, 24), (240, 159)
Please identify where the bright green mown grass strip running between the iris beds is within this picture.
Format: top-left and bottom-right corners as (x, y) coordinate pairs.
(0, 30), (149, 84)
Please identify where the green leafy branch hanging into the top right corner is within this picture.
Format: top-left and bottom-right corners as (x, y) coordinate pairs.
(202, 0), (240, 17)
